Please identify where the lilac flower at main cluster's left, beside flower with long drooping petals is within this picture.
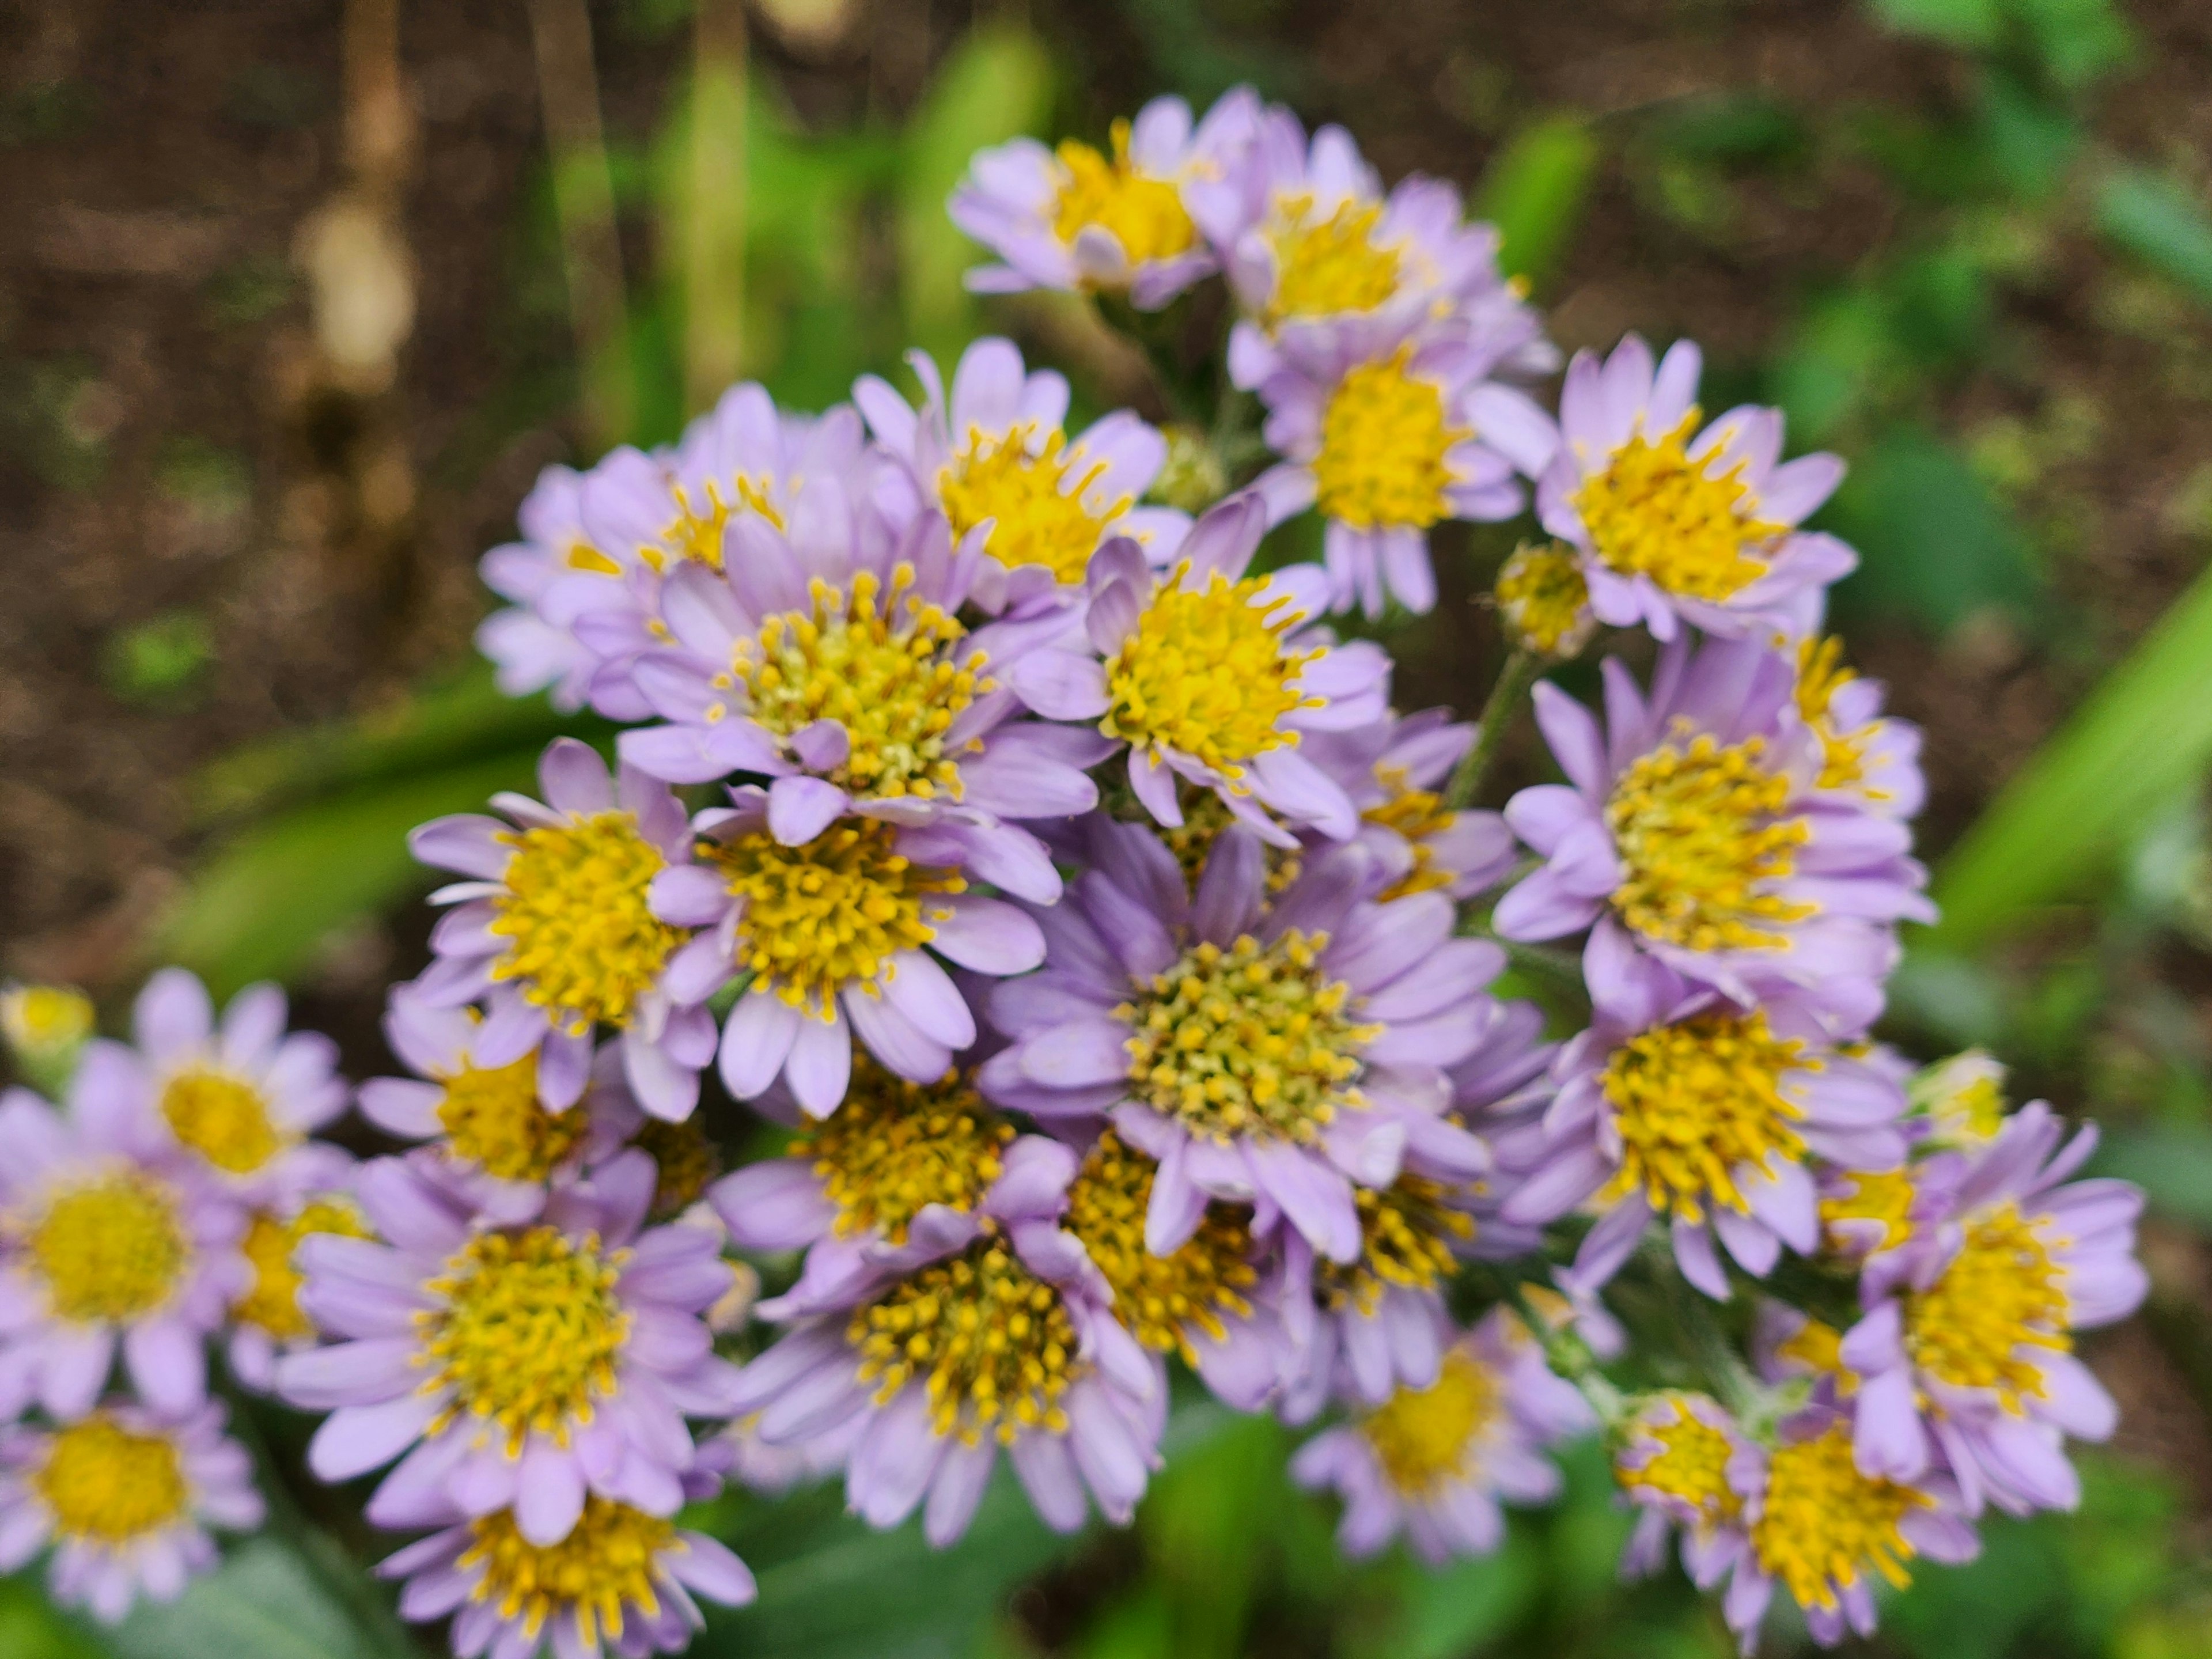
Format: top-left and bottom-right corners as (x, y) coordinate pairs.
(407, 737), (714, 1117)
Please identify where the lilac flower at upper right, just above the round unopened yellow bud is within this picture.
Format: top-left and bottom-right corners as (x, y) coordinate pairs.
(1537, 334), (1858, 639)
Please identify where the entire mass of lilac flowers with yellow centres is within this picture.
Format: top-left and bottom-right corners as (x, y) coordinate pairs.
(0, 74), (2143, 1659)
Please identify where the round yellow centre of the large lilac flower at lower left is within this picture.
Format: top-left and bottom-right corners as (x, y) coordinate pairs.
(416, 1228), (630, 1451)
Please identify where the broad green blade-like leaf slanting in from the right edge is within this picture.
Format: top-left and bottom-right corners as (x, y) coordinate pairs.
(1929, 555), (2212, 953)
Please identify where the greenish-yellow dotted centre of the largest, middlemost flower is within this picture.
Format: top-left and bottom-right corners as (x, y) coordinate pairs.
(1115, 929), (1382, 1141)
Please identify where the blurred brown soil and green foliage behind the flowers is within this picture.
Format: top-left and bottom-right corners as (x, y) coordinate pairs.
(0, 0), (2212, 1659)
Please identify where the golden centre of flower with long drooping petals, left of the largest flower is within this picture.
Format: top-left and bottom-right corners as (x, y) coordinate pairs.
(699, 821), (967, 1020)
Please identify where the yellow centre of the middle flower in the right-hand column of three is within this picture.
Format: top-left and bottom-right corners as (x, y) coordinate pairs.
(1606, 732), (1816, 951)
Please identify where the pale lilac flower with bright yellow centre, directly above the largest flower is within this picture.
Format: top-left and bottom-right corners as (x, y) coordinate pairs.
(1011, 493), (1389, 847)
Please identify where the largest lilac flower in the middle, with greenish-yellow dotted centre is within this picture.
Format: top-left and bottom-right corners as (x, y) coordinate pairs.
(978, 819), (1502, 1263)
